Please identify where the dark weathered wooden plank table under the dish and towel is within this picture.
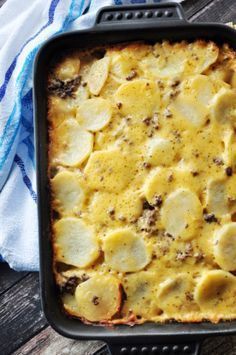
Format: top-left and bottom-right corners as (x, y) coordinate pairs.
(0, 0), (236, 355)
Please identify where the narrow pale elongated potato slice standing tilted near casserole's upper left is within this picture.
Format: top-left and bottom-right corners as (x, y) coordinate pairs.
(88, 57), (110, 95)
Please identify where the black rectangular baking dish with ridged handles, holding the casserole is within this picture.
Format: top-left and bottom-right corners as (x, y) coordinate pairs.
(34, 3), (236, 355)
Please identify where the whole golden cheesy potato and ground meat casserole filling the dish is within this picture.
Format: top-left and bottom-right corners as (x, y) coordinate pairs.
(48, 40), (236, 324)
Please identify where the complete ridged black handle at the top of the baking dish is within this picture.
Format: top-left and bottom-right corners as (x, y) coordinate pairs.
(95, 3), (187, 29)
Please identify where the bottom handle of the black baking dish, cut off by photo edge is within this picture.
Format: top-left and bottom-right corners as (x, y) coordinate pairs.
(94, 342), (201, 355)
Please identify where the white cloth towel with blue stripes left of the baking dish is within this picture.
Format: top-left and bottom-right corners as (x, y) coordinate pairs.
(0, 0), (183, 271)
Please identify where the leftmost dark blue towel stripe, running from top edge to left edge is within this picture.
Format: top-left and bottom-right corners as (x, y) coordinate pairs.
(0, 0), (60, 102)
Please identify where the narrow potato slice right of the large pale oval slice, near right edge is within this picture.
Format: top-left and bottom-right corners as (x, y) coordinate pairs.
(206, 178), (228, 217)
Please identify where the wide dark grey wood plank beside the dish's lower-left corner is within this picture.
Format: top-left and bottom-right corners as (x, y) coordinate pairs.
(0, 273), (46, 355)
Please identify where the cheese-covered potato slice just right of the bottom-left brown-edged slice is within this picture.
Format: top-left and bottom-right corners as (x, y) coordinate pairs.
(123, 271), (160, 318)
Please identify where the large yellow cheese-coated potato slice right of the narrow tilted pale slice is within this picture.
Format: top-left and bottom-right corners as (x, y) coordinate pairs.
(115, 79), (160, 118)
